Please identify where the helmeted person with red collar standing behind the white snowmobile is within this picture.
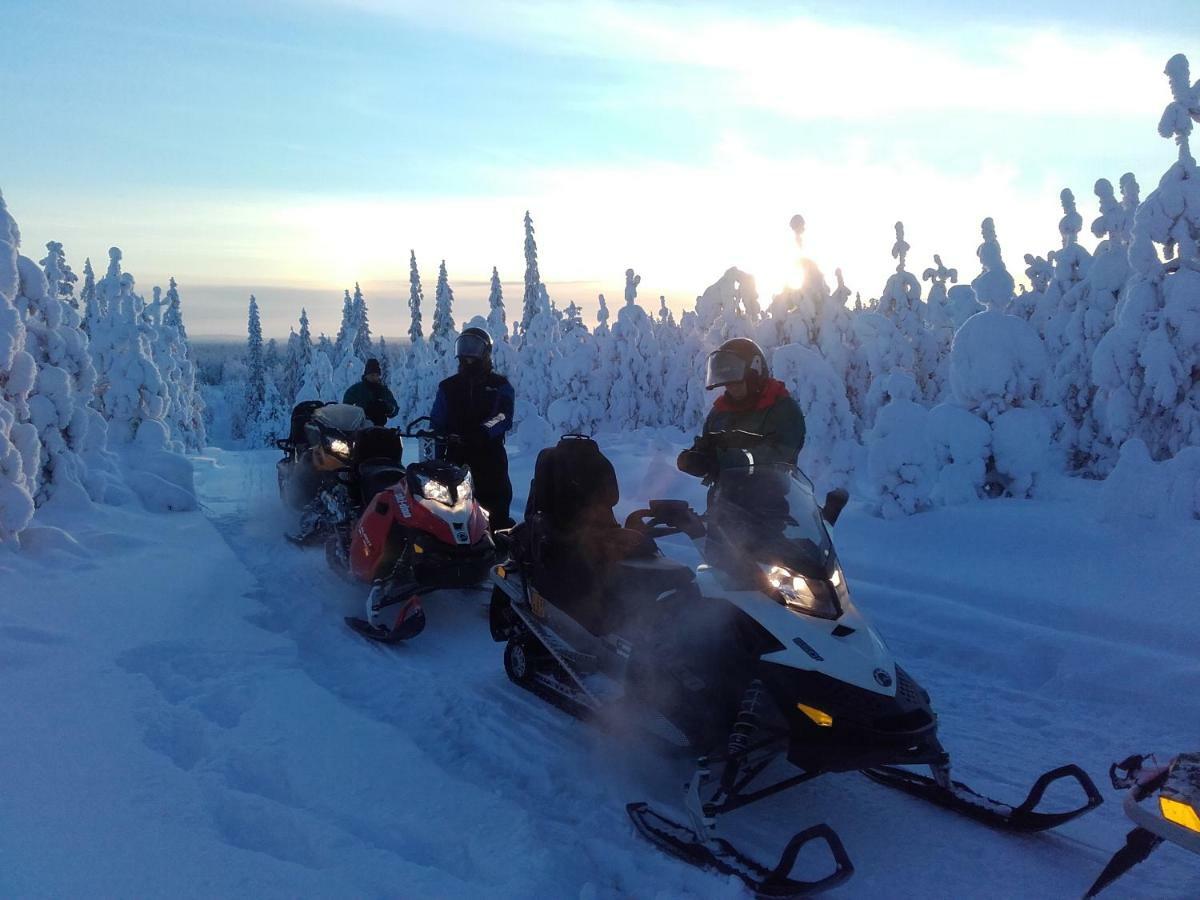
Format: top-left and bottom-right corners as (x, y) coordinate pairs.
(676, 337), (804, 481)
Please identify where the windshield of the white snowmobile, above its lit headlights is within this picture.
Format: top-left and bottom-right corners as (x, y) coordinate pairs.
(708, 463), (836, 578)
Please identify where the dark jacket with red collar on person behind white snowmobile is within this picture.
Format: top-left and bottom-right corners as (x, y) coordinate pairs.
(678, 378), (805, 478)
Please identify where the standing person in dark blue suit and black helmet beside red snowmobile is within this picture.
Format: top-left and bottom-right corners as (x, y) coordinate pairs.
(430, 328), (515, 532)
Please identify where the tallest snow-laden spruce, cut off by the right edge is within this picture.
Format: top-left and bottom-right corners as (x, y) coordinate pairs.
(1092, 54), (1200, 460)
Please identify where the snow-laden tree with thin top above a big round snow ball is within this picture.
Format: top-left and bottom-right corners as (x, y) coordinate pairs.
(950, 218), (1052, 497)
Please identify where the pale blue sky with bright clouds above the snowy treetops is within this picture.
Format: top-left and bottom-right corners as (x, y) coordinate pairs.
(0, 0), (1200, 338)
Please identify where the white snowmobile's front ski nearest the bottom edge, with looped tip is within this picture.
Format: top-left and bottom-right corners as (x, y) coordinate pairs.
(625, 803), (854, 900)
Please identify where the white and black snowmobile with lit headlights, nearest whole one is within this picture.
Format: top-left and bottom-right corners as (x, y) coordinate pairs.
(491, 436), (1102, 898)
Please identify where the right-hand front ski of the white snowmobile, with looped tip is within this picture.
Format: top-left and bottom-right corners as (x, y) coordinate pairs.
(863, 764), (1104, 833)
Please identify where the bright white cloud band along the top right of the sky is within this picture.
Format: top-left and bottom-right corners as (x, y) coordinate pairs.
(316, 0), (1177, 120)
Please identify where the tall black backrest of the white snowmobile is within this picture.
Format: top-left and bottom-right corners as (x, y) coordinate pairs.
(526, 437), (620, 535)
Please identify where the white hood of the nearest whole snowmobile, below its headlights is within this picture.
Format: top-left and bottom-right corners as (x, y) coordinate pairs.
(697, 565), (898, 697)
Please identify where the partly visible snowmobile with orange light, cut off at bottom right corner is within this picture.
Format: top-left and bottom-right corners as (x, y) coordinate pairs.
(1084, 752), (1200, 900)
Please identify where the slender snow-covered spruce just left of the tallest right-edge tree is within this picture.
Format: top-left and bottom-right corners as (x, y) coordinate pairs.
(1050, 178), (1133, 474)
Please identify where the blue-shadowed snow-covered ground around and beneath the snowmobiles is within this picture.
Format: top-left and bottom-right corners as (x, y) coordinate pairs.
(0, 433), (1200, 899)
